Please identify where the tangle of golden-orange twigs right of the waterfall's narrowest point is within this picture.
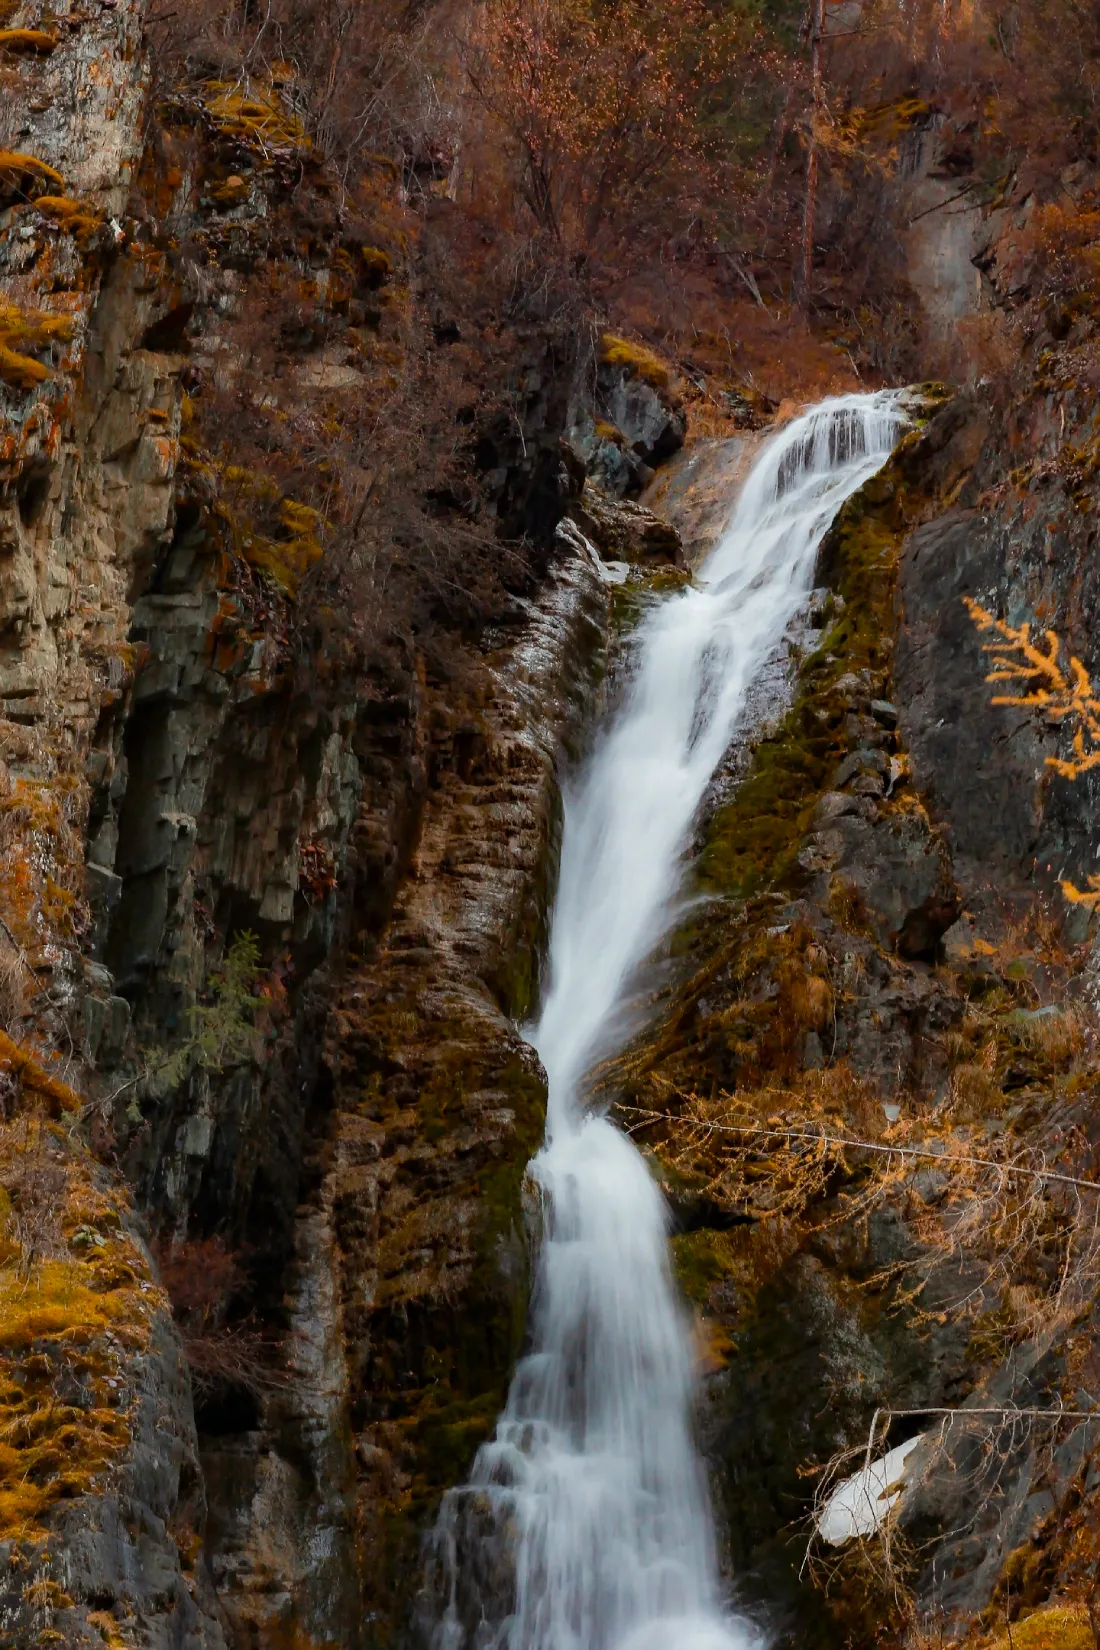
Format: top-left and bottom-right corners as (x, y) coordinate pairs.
(622, 1091), (1100, 1343)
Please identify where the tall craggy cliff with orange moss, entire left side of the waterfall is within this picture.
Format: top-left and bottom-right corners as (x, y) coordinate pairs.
(0, 0), (607, 1650)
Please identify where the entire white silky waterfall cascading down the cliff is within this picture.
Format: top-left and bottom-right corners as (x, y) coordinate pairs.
(430, 391), (904, 1650)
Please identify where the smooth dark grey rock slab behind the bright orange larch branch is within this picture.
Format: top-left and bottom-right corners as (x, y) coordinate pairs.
(897, 392), (1100, 916)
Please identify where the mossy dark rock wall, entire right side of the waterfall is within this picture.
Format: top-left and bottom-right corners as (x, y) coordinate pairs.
(609, 398), (1100, 1645)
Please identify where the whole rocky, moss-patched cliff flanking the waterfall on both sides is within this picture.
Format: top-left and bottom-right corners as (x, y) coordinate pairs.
(0, 0), (1100, 1650)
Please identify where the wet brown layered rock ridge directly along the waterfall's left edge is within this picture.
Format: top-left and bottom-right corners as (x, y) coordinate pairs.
(208, 521), (607, 1642)
